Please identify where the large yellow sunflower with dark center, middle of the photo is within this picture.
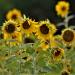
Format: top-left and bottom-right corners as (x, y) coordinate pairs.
(36, 20), (56, 40)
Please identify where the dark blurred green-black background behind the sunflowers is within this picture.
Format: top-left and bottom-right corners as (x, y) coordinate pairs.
(0, 0), (75, 25)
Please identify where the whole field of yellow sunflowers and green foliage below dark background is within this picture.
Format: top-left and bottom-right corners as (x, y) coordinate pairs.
(0, 0), (75, 75)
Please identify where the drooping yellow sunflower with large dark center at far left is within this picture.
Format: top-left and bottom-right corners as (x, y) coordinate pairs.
(2, 20), (17, 39)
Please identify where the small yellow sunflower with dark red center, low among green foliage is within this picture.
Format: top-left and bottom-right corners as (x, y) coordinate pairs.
(52, 48), (64, 61)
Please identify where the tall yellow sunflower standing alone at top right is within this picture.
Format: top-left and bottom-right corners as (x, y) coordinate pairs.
(55, 1), (70, 17)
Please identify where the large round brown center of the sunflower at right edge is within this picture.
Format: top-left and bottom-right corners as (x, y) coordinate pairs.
(63, 30), (74, 42)
